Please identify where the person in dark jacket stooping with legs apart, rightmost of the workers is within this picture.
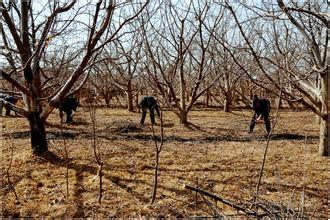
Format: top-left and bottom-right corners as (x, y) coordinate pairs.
(249, 95), (271, 133)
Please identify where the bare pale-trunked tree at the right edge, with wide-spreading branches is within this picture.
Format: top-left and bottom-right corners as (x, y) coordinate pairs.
(227, 0), (329, 156)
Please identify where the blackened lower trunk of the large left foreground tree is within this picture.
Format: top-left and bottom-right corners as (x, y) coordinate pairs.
(28, 112), (48, 155)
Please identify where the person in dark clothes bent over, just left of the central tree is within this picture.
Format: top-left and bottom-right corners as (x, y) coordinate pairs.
(139, 96), (160, 125)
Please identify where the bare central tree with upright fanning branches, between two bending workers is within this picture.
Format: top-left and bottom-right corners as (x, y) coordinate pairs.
(144, 1), (219, 124)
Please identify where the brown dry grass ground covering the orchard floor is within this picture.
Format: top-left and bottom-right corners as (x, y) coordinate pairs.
(1, 108), (329, 217)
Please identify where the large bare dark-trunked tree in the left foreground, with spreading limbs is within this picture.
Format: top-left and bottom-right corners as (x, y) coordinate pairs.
(0, 0), (148, 155)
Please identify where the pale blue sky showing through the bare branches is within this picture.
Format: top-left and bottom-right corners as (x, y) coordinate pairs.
(0, 0), (326, 66)
